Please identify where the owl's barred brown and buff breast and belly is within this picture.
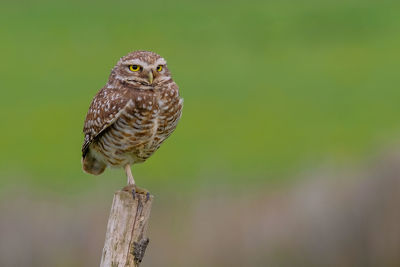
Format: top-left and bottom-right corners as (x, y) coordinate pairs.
(91, 84), (183, 166)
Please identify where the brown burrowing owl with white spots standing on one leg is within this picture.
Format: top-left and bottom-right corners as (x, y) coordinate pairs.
(82, 51), (183, 193)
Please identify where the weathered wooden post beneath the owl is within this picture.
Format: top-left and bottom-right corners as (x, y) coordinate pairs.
(100, 190), (154, 267)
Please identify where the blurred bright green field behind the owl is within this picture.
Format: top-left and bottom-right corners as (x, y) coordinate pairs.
(0, 0), (400, 191)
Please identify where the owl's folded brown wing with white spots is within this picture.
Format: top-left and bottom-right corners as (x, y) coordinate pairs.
(82, 88), (132, 157)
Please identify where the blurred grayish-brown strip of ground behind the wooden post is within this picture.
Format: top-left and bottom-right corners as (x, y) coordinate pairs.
(0, 150), (400, 267)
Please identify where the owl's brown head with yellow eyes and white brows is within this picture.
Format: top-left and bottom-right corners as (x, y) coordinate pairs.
(111, 51), (171, 86)
